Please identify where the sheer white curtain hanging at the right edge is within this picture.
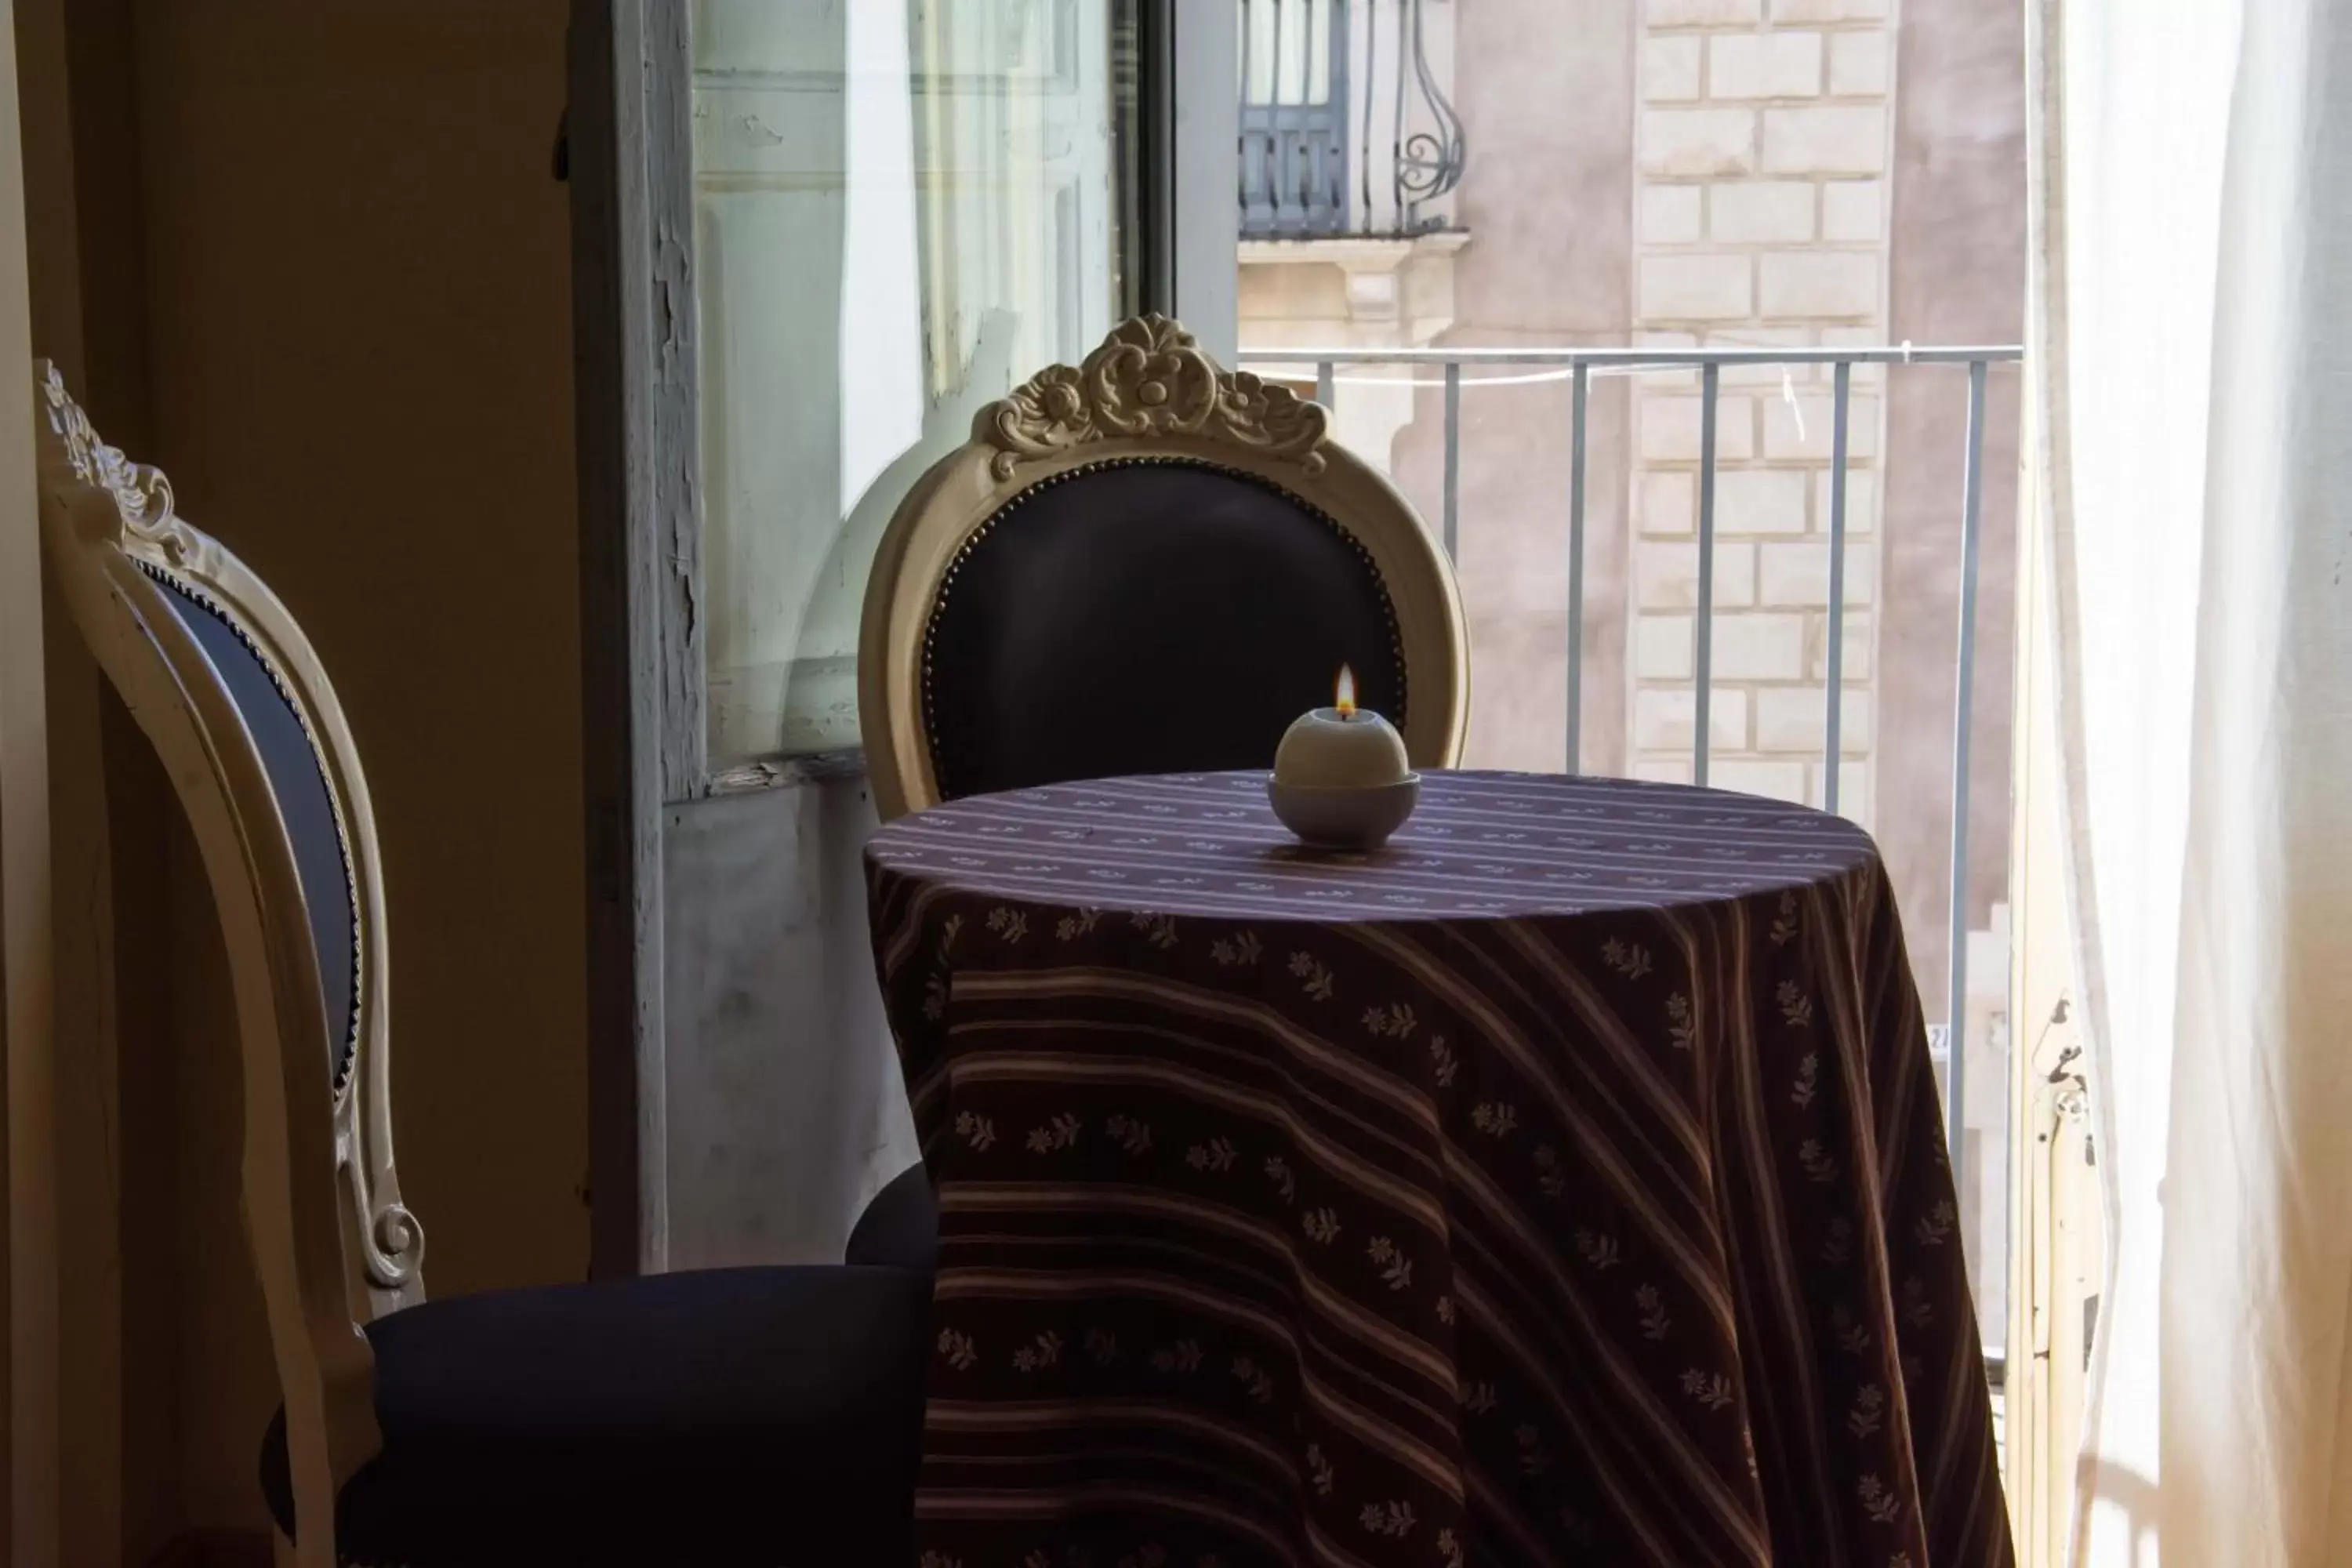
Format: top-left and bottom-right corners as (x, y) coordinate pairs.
(2030, 0), (2352, 1568)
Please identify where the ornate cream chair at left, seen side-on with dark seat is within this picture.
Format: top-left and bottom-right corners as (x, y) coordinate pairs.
(35, 367), (929, 1568)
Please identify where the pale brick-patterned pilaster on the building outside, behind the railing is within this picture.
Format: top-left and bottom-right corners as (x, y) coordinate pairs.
(1628, 0), (1896, 820)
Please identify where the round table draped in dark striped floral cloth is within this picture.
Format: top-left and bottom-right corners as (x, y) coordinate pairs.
(868, 774), (2011, 1568)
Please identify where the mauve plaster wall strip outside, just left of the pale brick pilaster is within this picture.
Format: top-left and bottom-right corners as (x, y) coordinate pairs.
(1395, 0), (1635, 774)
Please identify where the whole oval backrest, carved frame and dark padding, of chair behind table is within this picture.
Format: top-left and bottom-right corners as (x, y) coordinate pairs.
(858, 315), (1468, 820)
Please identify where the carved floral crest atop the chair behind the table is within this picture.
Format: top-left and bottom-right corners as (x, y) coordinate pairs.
(971, 315), (1329, 482)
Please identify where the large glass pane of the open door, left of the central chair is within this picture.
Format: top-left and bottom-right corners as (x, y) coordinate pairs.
(694, 0), (1136, 767)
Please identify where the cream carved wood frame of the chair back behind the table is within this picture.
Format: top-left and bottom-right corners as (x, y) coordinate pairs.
(858, 315), (1470, 822)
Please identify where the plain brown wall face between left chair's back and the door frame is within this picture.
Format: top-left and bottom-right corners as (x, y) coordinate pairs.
(136, 0), (586, 1295)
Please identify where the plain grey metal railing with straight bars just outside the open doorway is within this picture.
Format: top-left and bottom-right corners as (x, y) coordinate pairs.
(1240, 343), (2025, 1182)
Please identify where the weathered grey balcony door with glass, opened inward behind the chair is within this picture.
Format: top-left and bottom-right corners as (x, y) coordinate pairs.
(567, 0), (1235, 1274)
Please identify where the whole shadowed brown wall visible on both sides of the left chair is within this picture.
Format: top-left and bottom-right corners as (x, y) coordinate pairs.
(31, 0), (588, 1561)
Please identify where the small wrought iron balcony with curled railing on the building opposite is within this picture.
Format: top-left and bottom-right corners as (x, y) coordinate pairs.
(1235, 0), (1465, 240)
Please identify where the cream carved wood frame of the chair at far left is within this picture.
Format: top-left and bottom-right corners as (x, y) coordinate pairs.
(33, 362), (423, 1568)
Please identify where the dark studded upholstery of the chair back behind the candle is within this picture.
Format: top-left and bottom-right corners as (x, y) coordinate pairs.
(922, 459), (1411, 799)
